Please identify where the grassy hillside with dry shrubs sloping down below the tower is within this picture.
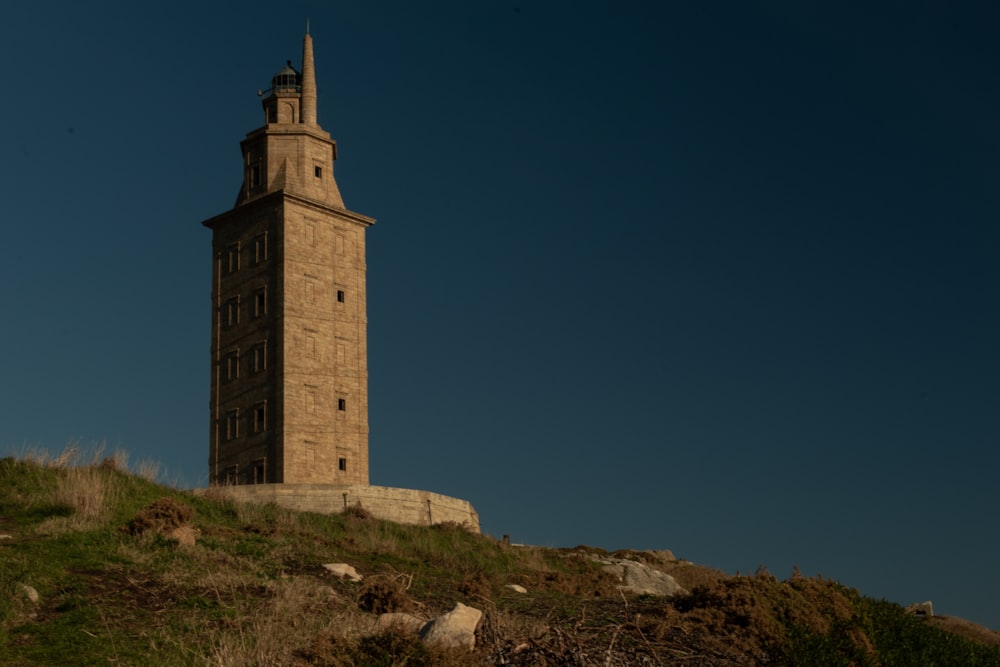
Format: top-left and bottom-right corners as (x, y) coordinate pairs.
(0, 455), (1000, 667)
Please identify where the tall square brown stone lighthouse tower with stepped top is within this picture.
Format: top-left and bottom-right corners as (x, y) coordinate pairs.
(202, 34), (375, 485)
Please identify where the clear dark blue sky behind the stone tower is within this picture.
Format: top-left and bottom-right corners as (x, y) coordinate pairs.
(0, 0), (1000, 630)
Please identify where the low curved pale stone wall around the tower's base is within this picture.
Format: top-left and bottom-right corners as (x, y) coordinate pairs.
(199, 484), (479, 533)
